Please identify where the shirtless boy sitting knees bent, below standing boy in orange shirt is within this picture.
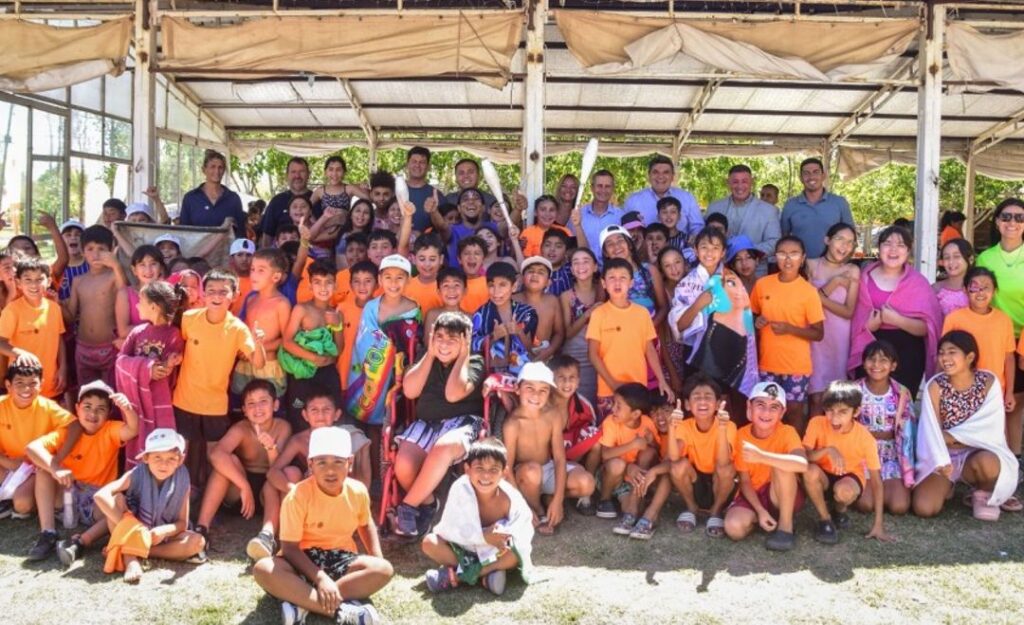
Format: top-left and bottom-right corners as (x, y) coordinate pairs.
(196, 378), (292, 560)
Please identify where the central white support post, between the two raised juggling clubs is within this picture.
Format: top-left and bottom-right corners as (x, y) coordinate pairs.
(522, 0), (548, 224)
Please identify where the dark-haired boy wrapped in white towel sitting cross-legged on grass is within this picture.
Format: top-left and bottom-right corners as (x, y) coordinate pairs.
(421, 439), (534, 594)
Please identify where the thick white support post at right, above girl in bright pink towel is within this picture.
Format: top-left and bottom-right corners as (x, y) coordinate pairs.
(913, 3), (946, 281)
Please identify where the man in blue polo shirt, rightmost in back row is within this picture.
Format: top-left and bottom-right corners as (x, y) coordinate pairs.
(781, 158), (854, 258)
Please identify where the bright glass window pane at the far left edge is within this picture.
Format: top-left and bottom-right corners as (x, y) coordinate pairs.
(0, 101), (29, 240)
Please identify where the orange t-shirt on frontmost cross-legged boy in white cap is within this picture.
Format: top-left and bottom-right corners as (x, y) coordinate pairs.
(281, 477), (370, 553)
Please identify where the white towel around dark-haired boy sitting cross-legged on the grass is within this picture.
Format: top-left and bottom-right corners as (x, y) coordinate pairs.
(434, 475), (534, 580)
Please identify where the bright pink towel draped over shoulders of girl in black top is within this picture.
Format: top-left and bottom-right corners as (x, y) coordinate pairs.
(846, 261), (942, 378)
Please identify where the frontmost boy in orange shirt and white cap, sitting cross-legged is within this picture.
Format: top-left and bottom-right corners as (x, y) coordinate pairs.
(253, 427), (394, 623)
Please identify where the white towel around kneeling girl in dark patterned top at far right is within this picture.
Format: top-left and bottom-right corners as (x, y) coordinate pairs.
(914, 373), (1018, 506)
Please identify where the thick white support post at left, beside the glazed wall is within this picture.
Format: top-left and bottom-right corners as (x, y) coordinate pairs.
(128, 0), (157, 201)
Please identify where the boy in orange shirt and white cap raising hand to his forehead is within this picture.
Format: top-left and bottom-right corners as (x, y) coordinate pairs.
(26, 380), (138, 567)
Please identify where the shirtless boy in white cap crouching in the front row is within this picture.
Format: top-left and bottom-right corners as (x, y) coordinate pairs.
(503, 363), (594, 535)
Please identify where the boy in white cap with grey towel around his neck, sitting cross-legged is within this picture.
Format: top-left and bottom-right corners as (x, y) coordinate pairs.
(93, 428), (206, 584)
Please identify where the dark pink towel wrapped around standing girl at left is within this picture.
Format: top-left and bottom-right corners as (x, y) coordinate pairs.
(116, 353), (175, 469)
